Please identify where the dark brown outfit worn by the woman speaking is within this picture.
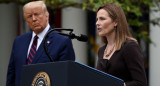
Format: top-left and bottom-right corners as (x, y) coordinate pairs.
(97, 40), (147, 86)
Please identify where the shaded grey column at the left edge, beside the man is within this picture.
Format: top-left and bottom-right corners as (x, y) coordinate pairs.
(0, 3), (18, 86)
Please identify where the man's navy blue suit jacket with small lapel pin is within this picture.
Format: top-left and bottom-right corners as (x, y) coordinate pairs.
(7, 29), (75, 86)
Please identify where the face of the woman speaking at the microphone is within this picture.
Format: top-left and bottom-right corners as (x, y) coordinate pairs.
(96, 9), (117, 36)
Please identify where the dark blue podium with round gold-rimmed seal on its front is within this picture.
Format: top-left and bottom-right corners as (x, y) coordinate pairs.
(20, 61), (124, 86)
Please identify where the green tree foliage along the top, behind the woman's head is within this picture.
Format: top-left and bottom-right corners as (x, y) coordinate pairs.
(0, 0), (160, 42)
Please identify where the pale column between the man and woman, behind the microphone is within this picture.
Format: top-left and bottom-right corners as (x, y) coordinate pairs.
(62, 7), (88, 64)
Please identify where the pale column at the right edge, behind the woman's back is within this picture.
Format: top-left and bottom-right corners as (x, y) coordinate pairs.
(149, 2), (160, 86)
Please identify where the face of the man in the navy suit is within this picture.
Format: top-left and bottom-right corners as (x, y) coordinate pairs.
(24, 5), (48, 34)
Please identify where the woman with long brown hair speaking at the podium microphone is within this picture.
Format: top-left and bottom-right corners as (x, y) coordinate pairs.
(96, 3), (147, 86)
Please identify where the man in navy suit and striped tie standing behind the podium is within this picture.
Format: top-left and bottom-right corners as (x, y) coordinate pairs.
(6, 1), (75, 86)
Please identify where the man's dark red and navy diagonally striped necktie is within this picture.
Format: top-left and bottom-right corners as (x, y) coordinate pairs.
(27, 35), (38, 64)
